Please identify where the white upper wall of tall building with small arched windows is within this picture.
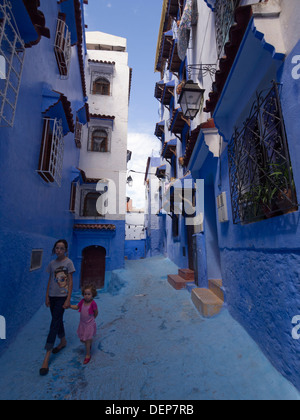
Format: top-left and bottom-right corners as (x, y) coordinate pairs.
(79, 32), (130, 220)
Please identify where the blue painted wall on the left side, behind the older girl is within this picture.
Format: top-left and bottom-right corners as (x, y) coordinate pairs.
(0, 0), (84, 351)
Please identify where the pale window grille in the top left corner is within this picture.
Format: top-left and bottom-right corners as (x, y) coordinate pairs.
(0, 2), (25, 127)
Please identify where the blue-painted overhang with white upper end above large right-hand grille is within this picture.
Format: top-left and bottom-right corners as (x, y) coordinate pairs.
(213, 0), (285, 141)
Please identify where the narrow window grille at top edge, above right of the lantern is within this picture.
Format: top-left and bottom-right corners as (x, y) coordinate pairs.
(215, 0), (240, 58)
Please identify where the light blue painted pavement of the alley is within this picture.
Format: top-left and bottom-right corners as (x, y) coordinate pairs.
(0, 257), (300, 401)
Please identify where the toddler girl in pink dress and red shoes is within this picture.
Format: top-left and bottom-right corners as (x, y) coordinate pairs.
(71, 286), (98, 365)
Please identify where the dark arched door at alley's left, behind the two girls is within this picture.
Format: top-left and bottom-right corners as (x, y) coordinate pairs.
(81, 246), (106, 289)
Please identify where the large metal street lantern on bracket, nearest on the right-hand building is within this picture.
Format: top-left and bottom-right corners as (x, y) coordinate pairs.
(178, 80), (205, 120)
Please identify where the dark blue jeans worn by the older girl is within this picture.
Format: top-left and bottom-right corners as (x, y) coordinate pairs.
(45, 297), (67, 351)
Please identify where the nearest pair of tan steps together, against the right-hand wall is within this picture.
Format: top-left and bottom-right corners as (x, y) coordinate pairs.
(192, 280), (224, 318)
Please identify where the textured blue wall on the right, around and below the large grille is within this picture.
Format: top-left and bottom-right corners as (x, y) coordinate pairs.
(214, 44), (300, 389)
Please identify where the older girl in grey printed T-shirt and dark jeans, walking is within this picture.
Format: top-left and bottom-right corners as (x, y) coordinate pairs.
(40, 239), (75, 376)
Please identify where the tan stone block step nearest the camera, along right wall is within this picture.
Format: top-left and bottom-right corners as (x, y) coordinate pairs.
(192, 288), (223, 318)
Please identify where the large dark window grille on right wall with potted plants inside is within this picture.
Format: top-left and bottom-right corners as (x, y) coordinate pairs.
(228, 83), (298, 224)
